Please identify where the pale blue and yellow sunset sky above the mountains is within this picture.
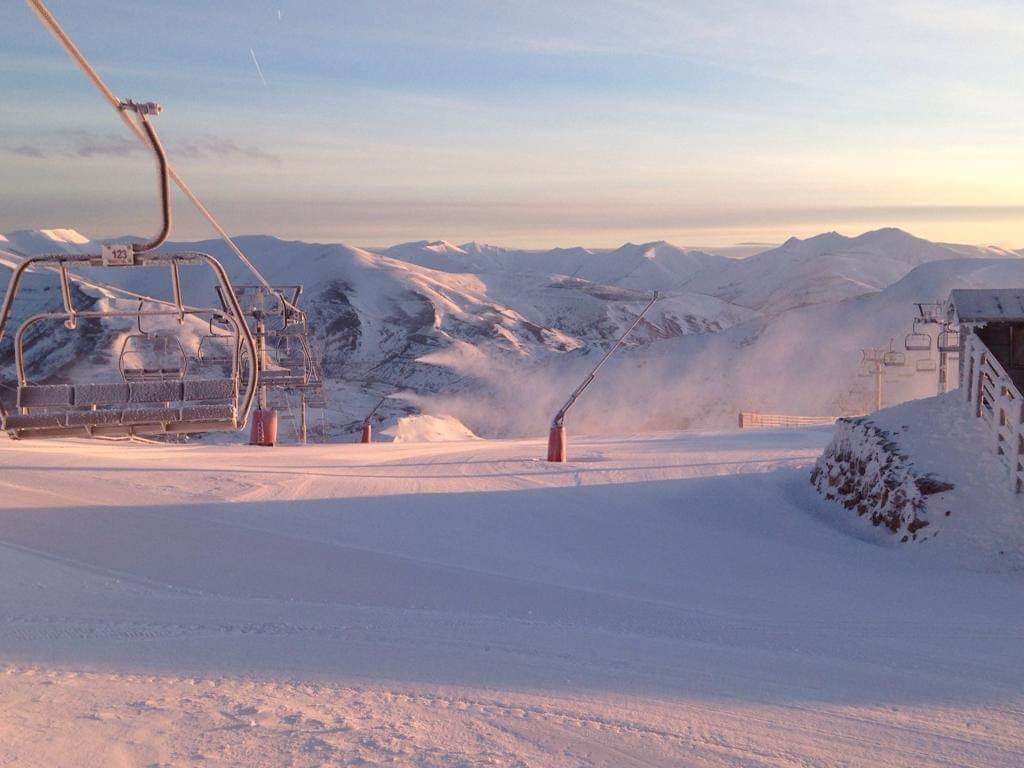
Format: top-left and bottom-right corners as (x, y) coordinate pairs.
(0, 0), (1024, 248)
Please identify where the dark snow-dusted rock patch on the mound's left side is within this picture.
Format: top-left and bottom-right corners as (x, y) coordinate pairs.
(811, 418), (952, 542)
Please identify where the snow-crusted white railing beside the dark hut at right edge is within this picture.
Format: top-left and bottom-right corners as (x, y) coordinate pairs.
(961, 334), (1024, 494)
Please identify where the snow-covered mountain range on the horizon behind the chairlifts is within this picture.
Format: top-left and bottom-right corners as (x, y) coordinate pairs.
(0, 229), (1024, 436)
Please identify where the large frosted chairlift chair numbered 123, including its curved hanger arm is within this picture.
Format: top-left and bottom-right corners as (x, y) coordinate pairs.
(0, 101), (258, 438)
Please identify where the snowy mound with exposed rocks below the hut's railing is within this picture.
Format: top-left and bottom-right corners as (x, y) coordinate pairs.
(811, 390), (1024, 569)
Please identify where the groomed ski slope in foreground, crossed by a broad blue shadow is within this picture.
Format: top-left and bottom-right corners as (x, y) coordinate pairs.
(0, 428), (1024, 767)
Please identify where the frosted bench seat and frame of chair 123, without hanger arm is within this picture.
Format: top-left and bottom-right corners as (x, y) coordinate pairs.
(0, 252), (259, 439)
